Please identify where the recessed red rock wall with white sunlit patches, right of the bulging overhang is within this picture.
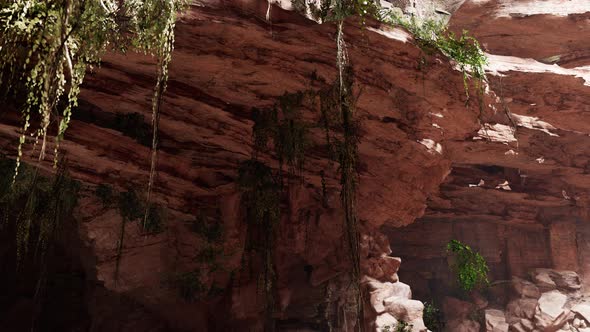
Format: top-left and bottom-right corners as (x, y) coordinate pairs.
(385, 0), (590, 306)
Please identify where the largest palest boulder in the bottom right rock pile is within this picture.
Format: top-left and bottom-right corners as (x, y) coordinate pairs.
(534, 290), (574, 331)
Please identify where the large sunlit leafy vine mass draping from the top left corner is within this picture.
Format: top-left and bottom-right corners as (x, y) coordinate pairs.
(0, 0), (188, 235)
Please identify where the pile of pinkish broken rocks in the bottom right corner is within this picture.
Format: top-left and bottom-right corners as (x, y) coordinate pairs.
(444, 269), (590, 332)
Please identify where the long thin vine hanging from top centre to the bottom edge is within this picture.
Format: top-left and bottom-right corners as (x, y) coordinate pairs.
(290, 0), (370, 331)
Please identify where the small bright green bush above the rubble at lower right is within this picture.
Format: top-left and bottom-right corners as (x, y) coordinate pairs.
(447, 240), (489, 292)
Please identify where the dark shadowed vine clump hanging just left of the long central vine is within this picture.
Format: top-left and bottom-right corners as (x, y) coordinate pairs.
(238, 91), (314, 331)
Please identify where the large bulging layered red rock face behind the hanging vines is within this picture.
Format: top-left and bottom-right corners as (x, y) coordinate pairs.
(0, 1), (478, 331)
